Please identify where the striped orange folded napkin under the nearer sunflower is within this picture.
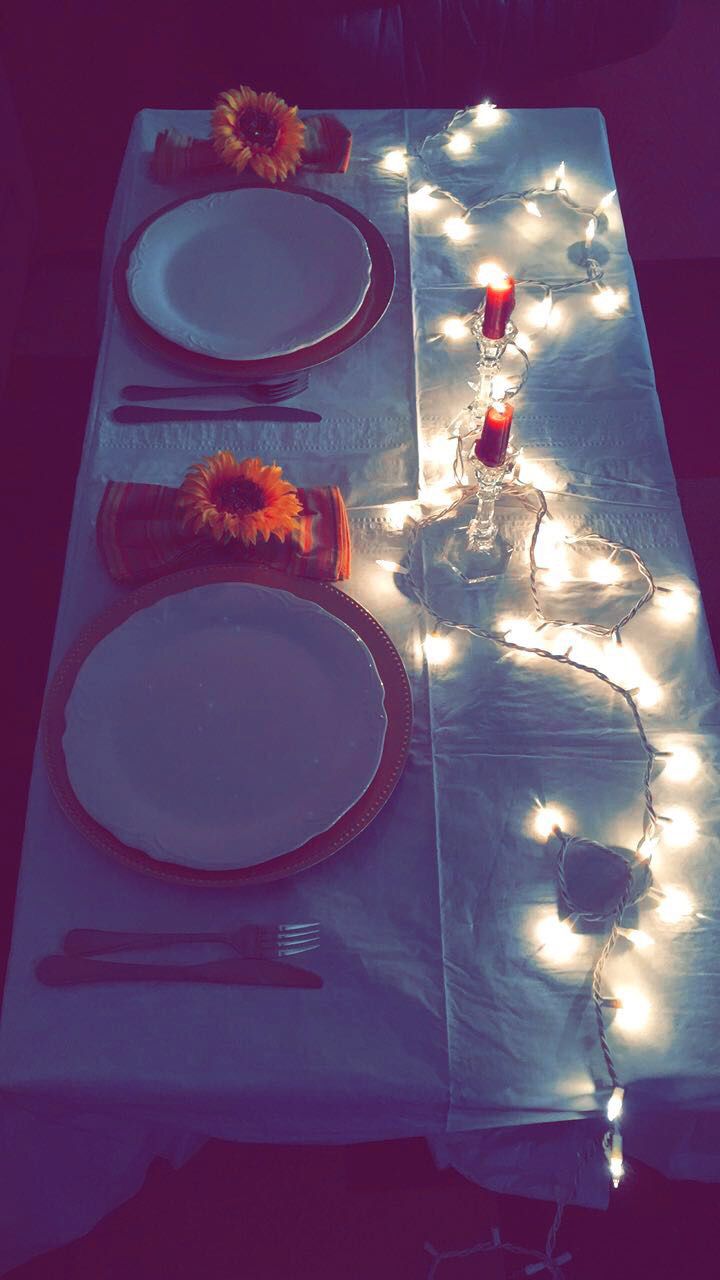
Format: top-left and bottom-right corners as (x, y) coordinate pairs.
(96, 480), (350, 585)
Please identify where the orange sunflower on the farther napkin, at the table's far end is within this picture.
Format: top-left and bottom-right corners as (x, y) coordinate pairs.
(213, 84), (305, 182)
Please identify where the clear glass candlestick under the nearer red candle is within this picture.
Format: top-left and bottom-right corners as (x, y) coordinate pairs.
(445, 449), (515, 585)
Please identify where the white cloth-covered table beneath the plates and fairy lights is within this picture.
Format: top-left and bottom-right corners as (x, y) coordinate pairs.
(0, 108), (720, 1272)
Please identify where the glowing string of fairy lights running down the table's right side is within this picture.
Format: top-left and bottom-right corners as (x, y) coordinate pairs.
(378, 102), (702, 1277)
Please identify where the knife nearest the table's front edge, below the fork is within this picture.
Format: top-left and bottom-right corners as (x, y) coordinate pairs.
(35, 956), (323, 989)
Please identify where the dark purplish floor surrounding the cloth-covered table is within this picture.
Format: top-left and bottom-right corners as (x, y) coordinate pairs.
(0, 0), (720, 1280)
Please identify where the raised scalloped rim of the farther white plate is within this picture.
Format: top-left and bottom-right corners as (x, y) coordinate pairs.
(127, 186), (373, 361)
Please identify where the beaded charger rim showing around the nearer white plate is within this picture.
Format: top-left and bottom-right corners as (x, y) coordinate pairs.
(41, 564), (413, 888)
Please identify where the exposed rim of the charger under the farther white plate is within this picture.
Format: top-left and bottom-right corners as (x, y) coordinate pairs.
(113, 182), (396, 381)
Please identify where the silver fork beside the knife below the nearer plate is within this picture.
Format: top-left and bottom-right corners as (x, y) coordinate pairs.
(63, 923), (320, 960)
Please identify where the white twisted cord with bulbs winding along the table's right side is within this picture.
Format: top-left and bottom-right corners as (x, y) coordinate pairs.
(379, 102), (696, 1280)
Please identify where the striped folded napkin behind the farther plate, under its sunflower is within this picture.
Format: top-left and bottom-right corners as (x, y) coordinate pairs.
(150, 115), (352, 183)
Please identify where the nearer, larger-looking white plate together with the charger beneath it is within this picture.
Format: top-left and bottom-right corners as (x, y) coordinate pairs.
(44, 566), (411, 884)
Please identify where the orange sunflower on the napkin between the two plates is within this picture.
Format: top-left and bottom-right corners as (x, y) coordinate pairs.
(178, 452), (302, 547)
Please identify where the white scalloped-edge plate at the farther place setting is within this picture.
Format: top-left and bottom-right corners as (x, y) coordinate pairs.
(127, 187), (372, 360)
